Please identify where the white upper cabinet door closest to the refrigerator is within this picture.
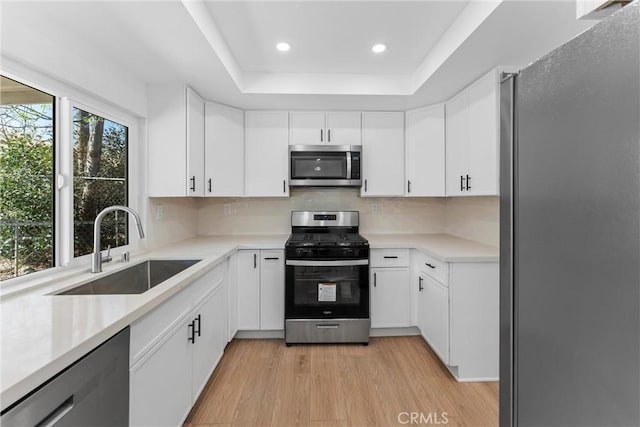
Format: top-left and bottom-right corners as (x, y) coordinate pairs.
(467, 71), (499, 196)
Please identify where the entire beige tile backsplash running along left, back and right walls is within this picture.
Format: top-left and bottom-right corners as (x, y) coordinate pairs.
(145, 188), (500, 248)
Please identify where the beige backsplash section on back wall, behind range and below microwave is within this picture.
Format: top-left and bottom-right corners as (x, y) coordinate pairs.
(198, 188), (445, 236)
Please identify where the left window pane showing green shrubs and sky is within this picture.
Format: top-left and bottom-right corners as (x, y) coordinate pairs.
(0, 76), (55, 280)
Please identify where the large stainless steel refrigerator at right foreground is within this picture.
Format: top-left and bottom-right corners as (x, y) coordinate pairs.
(500, 1), (640, 426)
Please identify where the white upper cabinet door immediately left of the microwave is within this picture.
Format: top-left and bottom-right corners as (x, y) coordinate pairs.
(245, 111), (289, 197)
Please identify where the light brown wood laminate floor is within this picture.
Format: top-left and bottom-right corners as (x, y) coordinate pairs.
(185, 336), (498, 427)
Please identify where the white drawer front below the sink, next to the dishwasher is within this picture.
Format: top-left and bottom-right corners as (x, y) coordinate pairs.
(129, 288), (191, 366)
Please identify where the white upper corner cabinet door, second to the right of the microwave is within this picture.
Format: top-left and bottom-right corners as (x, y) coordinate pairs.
(405, 104), (445, 197)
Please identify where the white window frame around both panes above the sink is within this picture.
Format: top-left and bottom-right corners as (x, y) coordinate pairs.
(0, 71), (141, 289)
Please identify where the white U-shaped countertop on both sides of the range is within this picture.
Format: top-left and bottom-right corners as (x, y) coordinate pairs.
(0, 233), (498, 410)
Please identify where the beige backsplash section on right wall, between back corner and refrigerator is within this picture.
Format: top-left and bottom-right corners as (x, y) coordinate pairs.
(444, 197), (500, 246)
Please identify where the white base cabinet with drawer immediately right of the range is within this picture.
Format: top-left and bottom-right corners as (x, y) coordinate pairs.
(369, 249), (411, 328)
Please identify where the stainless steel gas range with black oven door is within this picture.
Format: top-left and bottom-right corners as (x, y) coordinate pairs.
(285, 211), (371, 345)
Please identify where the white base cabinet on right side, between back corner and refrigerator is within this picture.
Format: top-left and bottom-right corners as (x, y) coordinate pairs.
(412, 251), (500, 381)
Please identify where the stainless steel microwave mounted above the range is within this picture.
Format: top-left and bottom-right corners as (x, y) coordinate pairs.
(289, 145), (362, 187)
